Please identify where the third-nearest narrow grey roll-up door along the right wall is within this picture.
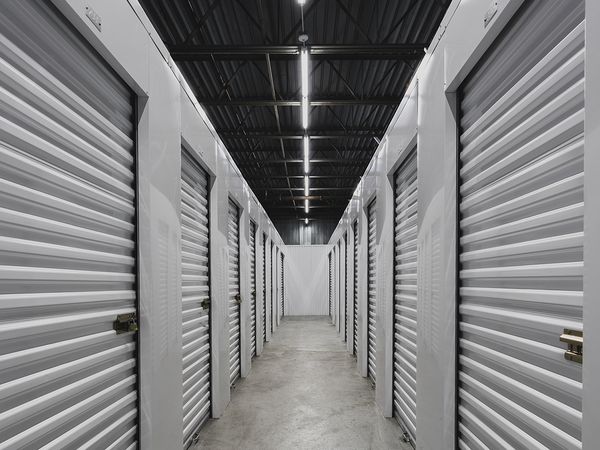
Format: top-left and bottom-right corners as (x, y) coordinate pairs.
(367, 199), (377, 383)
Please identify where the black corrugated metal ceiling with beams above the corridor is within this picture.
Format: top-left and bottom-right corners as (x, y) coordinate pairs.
(141, 0), (450, 230)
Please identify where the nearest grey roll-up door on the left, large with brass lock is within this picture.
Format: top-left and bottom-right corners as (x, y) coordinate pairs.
(0, 1), (138, 449)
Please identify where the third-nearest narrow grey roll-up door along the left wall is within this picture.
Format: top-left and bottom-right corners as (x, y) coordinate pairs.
(227, 199), (241, 384)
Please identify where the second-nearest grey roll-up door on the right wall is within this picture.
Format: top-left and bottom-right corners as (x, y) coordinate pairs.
(393, 148), (417, 445)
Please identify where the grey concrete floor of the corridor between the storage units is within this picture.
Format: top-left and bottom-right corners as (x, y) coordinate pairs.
(195, 317), (411, 450)
